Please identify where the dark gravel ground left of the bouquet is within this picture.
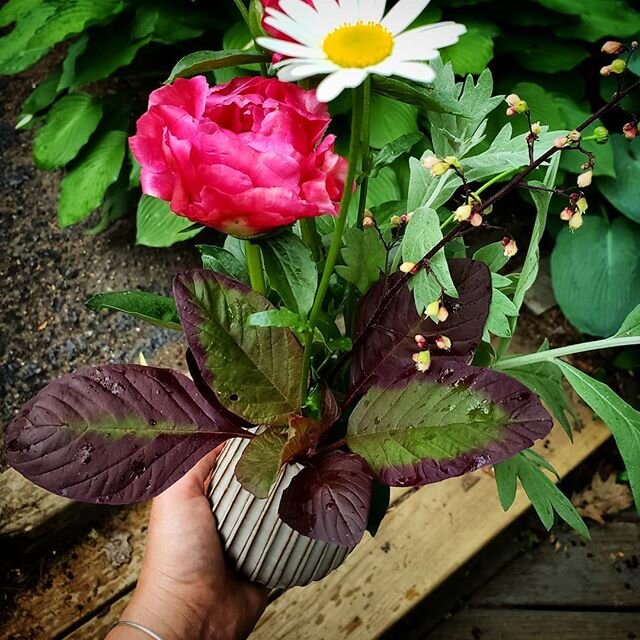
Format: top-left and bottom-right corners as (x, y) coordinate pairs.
(0, 61), (198, 438)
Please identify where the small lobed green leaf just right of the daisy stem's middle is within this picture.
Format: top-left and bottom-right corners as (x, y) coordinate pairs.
(336, 227), (387, 294)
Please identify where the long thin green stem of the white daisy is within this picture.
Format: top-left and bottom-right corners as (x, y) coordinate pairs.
(300, 85), (364, 403)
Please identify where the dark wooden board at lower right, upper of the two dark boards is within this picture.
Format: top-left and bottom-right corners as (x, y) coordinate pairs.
(471, 522), (640, 610)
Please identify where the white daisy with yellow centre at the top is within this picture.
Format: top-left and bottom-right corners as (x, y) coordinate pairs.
(257, 0), (466, 102)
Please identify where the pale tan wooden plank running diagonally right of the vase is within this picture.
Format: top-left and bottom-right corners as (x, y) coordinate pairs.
(251, 405), (610, 640)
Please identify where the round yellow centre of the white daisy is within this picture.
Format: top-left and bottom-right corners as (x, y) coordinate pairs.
(322, 22), (393, 69)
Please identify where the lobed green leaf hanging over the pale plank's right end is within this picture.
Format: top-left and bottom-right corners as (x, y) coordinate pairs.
(494, 452), (590, 539)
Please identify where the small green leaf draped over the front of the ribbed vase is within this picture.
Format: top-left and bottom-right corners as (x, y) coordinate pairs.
(236, 427), (287, 499)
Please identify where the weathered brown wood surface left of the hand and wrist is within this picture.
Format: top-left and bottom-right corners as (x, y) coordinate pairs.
(0, 504), (150, 640)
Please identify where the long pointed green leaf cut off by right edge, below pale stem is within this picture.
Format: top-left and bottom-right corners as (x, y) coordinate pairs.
(555, 360), (640, 508)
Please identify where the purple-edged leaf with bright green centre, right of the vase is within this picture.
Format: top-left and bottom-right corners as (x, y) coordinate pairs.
(347, 360), (553, 486)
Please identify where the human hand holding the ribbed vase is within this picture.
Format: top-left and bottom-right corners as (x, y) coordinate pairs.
(108, 449), (267, 640)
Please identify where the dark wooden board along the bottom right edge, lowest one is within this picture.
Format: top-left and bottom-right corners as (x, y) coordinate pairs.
(423, 609), (640, 640)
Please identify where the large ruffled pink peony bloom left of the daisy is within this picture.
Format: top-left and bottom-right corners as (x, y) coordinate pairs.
(129, 76), (347, 237)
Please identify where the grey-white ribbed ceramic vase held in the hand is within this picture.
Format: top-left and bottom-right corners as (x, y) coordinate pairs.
(209, 439), (351, 589)
